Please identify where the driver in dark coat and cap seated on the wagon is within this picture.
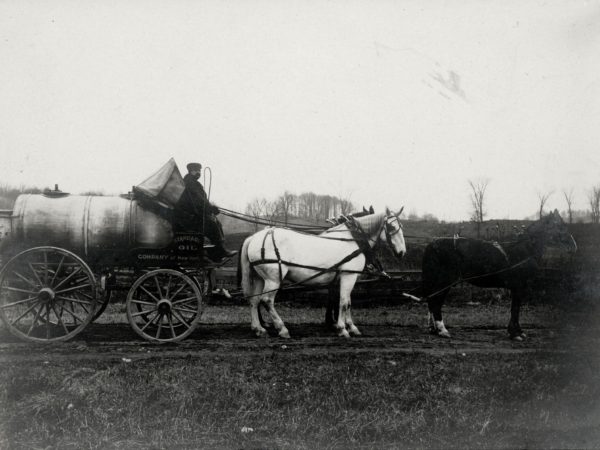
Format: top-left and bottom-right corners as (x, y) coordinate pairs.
(175, 163), (237, 261)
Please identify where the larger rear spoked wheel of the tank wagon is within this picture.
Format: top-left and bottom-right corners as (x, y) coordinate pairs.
(0, 247), (98, 342)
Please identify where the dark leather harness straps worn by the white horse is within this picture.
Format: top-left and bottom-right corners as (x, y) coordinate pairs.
(250, 216), (400, 284)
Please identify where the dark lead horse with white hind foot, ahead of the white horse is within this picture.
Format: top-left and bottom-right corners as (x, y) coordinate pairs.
(422, 210), (577, 340)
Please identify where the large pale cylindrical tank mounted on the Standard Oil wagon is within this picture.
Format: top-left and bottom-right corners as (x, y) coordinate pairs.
(2, 194), (174, 264)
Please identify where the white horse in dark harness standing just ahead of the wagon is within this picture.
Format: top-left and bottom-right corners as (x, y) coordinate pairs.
(240, 208), (406, 338)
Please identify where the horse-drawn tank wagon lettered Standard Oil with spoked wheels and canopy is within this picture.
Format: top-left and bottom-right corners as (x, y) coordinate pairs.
(0, 160), (224, 342)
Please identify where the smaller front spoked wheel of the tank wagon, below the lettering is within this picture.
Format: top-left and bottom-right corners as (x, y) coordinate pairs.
(125, 269), (202, 342)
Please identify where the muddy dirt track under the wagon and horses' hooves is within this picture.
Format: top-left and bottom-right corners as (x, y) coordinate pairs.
(0, 306), (600, 362)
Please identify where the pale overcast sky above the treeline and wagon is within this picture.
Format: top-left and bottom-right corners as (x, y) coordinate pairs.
(0, 0), (600, 220)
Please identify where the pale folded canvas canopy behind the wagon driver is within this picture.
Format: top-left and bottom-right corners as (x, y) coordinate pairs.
(133, 158), (185, 209)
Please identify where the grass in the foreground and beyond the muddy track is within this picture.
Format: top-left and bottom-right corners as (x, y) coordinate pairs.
(0, 290), (600, 449)
